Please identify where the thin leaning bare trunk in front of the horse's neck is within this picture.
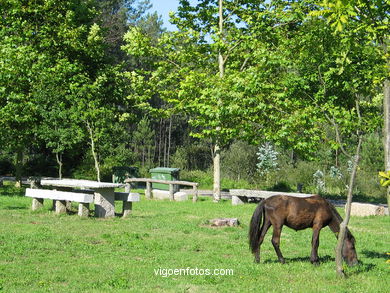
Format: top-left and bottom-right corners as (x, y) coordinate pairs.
(336, 134), (363, 277)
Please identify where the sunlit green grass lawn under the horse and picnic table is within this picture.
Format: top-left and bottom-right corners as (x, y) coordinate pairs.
(0, 186), (390, 292)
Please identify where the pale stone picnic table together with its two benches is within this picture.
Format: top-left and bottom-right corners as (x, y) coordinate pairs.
(26, 179), (139, 218)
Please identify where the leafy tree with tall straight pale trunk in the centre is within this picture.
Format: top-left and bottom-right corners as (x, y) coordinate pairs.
(124, 1), (274, 201)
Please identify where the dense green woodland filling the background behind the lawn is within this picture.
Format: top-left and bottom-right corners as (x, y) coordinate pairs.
(0, 0), (390, 202)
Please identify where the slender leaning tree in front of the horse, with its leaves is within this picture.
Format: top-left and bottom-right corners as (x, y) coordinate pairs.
(314, 0), (390, 276)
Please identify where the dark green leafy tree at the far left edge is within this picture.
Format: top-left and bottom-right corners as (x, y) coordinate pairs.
(0, 0), (97, 182)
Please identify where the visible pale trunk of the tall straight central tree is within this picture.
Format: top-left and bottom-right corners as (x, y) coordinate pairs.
(213, 0), (225, 202)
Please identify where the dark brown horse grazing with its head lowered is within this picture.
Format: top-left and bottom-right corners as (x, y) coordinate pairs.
(249, 195), (357, 265)
